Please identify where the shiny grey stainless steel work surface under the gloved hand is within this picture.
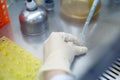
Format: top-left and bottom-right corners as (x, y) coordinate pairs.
(9, 0), (120, 78)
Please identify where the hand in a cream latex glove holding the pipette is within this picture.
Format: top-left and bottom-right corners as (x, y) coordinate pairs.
(40, 32), (88, 74)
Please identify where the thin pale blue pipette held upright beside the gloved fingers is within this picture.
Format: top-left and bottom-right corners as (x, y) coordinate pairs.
(81, 0), (99, 45)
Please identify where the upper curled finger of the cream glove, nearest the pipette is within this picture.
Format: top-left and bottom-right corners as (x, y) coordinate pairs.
(59, 32), (81, 45)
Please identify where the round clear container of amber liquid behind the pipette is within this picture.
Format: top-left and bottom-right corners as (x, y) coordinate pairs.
(60, 0), (101, 19)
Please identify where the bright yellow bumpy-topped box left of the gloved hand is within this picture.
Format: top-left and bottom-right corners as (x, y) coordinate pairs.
(0, 37), (42, 80)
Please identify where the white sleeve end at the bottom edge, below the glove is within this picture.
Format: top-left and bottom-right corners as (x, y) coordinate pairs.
(50, 74), (76, 80)
